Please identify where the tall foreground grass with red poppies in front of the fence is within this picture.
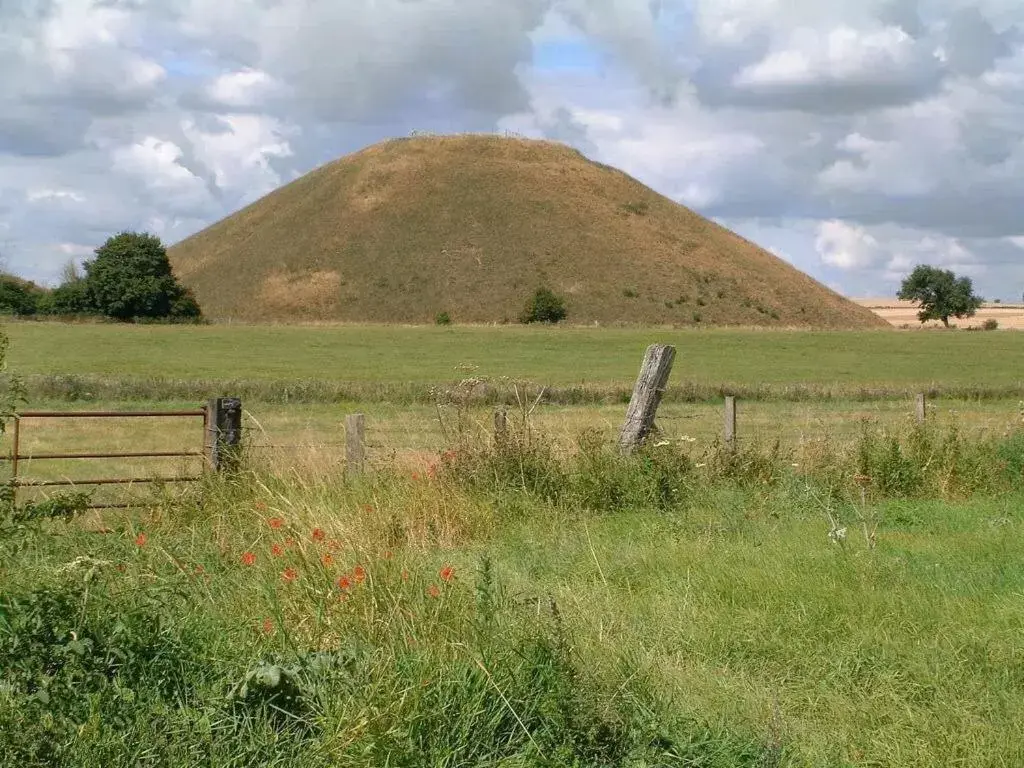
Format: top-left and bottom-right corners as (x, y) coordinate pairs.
(0, 412), (1024, 768)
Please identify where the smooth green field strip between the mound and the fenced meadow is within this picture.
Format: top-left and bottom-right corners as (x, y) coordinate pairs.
(7, 323), (1024, 399)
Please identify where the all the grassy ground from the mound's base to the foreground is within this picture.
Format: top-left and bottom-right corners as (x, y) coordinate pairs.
(0, 324), (1024, 768)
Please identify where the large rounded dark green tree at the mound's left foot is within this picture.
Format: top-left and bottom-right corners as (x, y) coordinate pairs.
(83, 231), (200, 321)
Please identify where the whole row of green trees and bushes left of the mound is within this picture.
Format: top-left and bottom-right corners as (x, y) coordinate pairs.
(0, 231), (203, 323)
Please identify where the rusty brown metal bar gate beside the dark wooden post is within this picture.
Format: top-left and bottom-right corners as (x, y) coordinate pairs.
(0, 408), (210, 509)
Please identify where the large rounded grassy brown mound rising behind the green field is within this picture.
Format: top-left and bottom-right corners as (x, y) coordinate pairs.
(169, 135), (886, 328)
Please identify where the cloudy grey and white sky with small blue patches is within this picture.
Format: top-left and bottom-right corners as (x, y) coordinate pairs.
(0, 0), (1024, 300)
